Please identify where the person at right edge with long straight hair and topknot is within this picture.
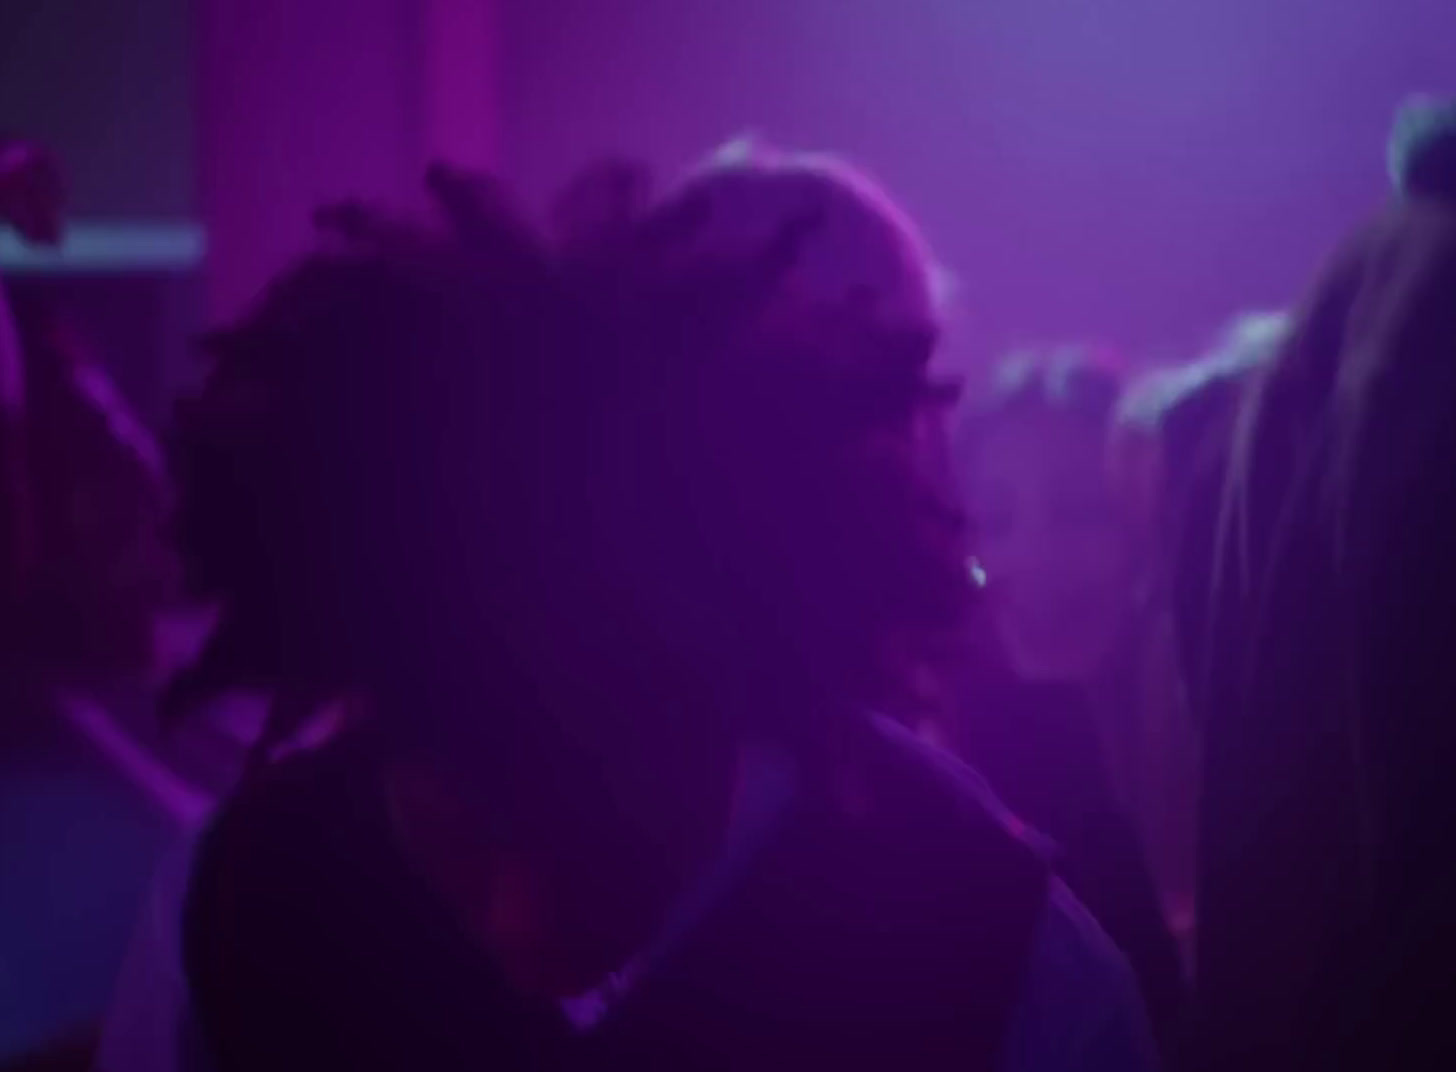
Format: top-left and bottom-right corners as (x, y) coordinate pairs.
(1184, 96), (1456, 1071)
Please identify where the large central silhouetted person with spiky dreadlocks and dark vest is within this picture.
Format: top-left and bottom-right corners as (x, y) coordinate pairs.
(165, 151), (1153, 1072)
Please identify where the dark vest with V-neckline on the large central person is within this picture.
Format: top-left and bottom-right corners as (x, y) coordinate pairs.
(185, 719), (1047, 1072)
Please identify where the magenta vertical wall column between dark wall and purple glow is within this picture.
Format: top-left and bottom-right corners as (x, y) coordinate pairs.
(197, 0), (498, 320)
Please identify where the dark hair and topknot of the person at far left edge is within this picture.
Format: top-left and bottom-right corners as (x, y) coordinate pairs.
(0, 136), (176, 686)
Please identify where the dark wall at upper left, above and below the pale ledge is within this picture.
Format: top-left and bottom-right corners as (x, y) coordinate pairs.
(0, 0), (201, 424)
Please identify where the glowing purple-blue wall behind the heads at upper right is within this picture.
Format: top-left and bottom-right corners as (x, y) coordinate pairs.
(499, 0), (1456, 355)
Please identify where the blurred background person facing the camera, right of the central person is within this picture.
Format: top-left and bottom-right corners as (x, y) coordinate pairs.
(948, 348), (1184, 1044)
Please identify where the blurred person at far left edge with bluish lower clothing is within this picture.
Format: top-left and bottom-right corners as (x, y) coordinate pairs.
(0, 141), (173, 1069)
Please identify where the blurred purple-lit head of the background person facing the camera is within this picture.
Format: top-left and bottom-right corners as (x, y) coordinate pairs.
(958, 348), (1137, 699)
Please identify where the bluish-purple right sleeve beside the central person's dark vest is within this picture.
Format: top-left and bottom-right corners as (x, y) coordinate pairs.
(1000, 883), (1158, 1072)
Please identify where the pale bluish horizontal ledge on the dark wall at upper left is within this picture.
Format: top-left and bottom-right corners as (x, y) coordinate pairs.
(0, 220), (207, 275)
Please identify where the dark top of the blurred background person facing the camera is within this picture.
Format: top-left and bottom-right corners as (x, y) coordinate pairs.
(955, 670), (1187, 1043)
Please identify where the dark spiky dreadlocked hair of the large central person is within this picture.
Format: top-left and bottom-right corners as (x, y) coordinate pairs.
(169, 148), (961, 778)
